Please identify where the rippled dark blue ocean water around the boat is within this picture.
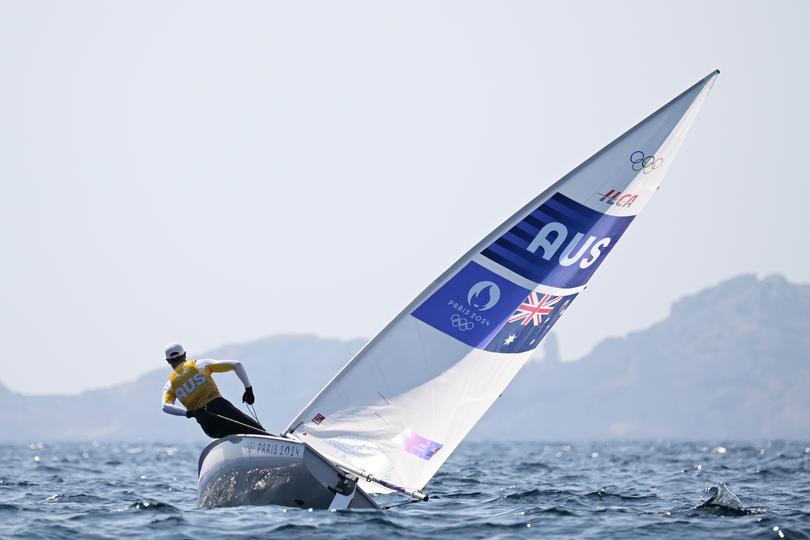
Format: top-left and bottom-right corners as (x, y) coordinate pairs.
(0, 441), (810, 540)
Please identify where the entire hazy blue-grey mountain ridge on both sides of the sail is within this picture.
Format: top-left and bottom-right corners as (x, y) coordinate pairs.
(0, 274), (810, 440)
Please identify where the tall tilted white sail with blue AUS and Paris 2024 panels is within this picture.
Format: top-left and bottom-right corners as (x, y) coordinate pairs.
(285, 71), (719, 492)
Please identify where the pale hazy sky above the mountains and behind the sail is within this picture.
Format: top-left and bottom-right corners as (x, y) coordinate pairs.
(0, 0), (810, 394)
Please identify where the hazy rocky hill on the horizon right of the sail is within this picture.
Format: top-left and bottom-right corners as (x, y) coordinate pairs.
(480, 275), (810, 439)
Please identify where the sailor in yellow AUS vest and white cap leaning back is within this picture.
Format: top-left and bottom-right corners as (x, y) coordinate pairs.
(163, 343), (266, 439)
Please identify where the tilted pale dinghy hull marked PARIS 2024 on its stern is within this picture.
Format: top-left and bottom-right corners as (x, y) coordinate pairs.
(197, 435), (379, 510)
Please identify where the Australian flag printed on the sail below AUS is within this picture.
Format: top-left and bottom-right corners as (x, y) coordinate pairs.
(484, 291), (577, 353)
